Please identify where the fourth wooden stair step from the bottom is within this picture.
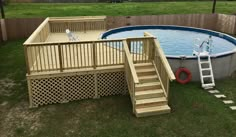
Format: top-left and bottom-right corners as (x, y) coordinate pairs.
(135, 82), (161, 91)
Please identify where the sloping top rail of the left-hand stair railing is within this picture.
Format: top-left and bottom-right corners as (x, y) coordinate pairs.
(123, 40), (139, 84)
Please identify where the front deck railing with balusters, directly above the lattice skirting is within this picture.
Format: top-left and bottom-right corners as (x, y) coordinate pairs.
(24, 40), (124, 74)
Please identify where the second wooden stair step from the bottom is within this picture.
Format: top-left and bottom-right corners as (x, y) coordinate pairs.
(136, 97), (167, 108)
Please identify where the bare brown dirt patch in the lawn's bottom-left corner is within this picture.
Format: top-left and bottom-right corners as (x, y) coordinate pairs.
(0, 102), (42, 137)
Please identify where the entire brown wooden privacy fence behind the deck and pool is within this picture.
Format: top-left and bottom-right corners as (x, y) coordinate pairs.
(0, 14), (236, 41)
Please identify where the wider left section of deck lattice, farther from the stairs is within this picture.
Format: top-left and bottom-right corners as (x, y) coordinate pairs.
(30, 74), (95, 107)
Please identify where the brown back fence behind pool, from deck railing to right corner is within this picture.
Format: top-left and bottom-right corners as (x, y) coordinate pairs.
(107, 14), (217, 30)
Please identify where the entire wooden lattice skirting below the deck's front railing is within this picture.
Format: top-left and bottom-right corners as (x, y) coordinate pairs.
(27, 70), (128, 107)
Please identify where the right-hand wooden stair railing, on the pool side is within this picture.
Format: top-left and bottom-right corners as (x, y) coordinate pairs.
(144, 32), (175, 98)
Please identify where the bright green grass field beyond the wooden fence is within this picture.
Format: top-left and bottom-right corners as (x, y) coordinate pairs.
(5, 1), (236, 18)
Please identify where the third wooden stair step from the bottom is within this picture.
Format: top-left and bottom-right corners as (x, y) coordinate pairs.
(135, 89), (164, 99)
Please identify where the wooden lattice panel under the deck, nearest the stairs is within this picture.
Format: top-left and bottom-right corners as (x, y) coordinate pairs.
(97, 71), (127, 96)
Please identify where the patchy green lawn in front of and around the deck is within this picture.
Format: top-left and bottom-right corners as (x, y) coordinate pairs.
(0, 40), (236, 137)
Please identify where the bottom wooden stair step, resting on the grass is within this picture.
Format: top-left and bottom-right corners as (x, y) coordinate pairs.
(136, 105), (170, 117)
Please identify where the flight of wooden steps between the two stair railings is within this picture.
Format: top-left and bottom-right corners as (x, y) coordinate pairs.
(134, 62), (170, 117)
